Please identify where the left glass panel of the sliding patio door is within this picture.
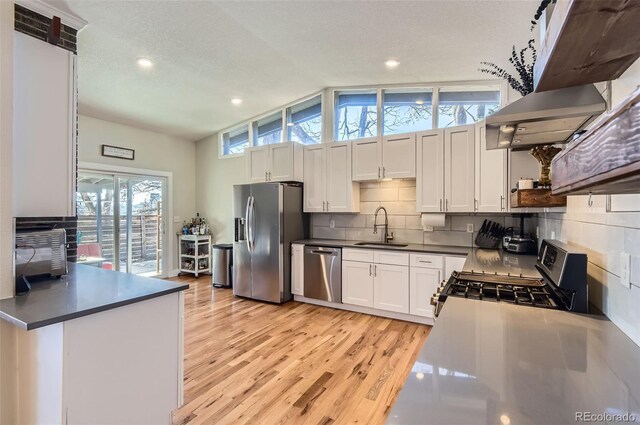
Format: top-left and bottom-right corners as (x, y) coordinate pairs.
(76, 172), (115, 270)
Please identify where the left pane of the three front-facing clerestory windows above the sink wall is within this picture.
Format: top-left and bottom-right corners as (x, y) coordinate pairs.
(335, 91), (378, 141)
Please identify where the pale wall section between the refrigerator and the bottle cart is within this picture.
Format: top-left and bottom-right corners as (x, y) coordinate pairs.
(196, 134), (245, 243)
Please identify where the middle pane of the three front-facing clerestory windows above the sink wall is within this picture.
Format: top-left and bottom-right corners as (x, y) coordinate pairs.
(382, 89), (433, 134)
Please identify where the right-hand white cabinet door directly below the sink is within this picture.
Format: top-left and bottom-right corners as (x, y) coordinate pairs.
(373, 264), (409, 314)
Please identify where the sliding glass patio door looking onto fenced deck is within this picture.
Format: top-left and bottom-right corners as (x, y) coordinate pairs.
(76, 170), (167, 276)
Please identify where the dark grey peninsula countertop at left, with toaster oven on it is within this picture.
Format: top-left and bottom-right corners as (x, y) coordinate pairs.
(0, 263), (189, 330)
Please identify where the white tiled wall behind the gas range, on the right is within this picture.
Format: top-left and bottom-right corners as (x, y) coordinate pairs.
(539, 62), (640, 345)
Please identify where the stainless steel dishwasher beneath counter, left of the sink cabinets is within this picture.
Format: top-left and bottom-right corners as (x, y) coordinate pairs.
(304, 246), (342, 303)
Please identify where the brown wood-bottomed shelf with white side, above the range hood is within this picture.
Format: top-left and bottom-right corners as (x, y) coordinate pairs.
(533, 0), (640, 92)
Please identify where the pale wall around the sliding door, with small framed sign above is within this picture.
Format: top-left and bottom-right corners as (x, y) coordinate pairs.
(78, 115), (196, 270)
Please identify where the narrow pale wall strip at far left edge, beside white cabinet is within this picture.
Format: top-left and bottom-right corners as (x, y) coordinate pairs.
(0, 1), (17, 424)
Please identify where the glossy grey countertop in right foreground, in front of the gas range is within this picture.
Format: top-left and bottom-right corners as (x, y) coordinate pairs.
(387, 298), (640, 425)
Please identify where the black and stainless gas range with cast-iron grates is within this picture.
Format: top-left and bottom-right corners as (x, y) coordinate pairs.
(431, 240), (588, 317)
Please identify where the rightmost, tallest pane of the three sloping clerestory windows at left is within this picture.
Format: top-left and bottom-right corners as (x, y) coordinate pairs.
(287, 95), (322, 145)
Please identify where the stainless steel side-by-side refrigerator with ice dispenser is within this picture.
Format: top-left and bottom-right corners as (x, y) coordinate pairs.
(233, 183), (309, 303)
